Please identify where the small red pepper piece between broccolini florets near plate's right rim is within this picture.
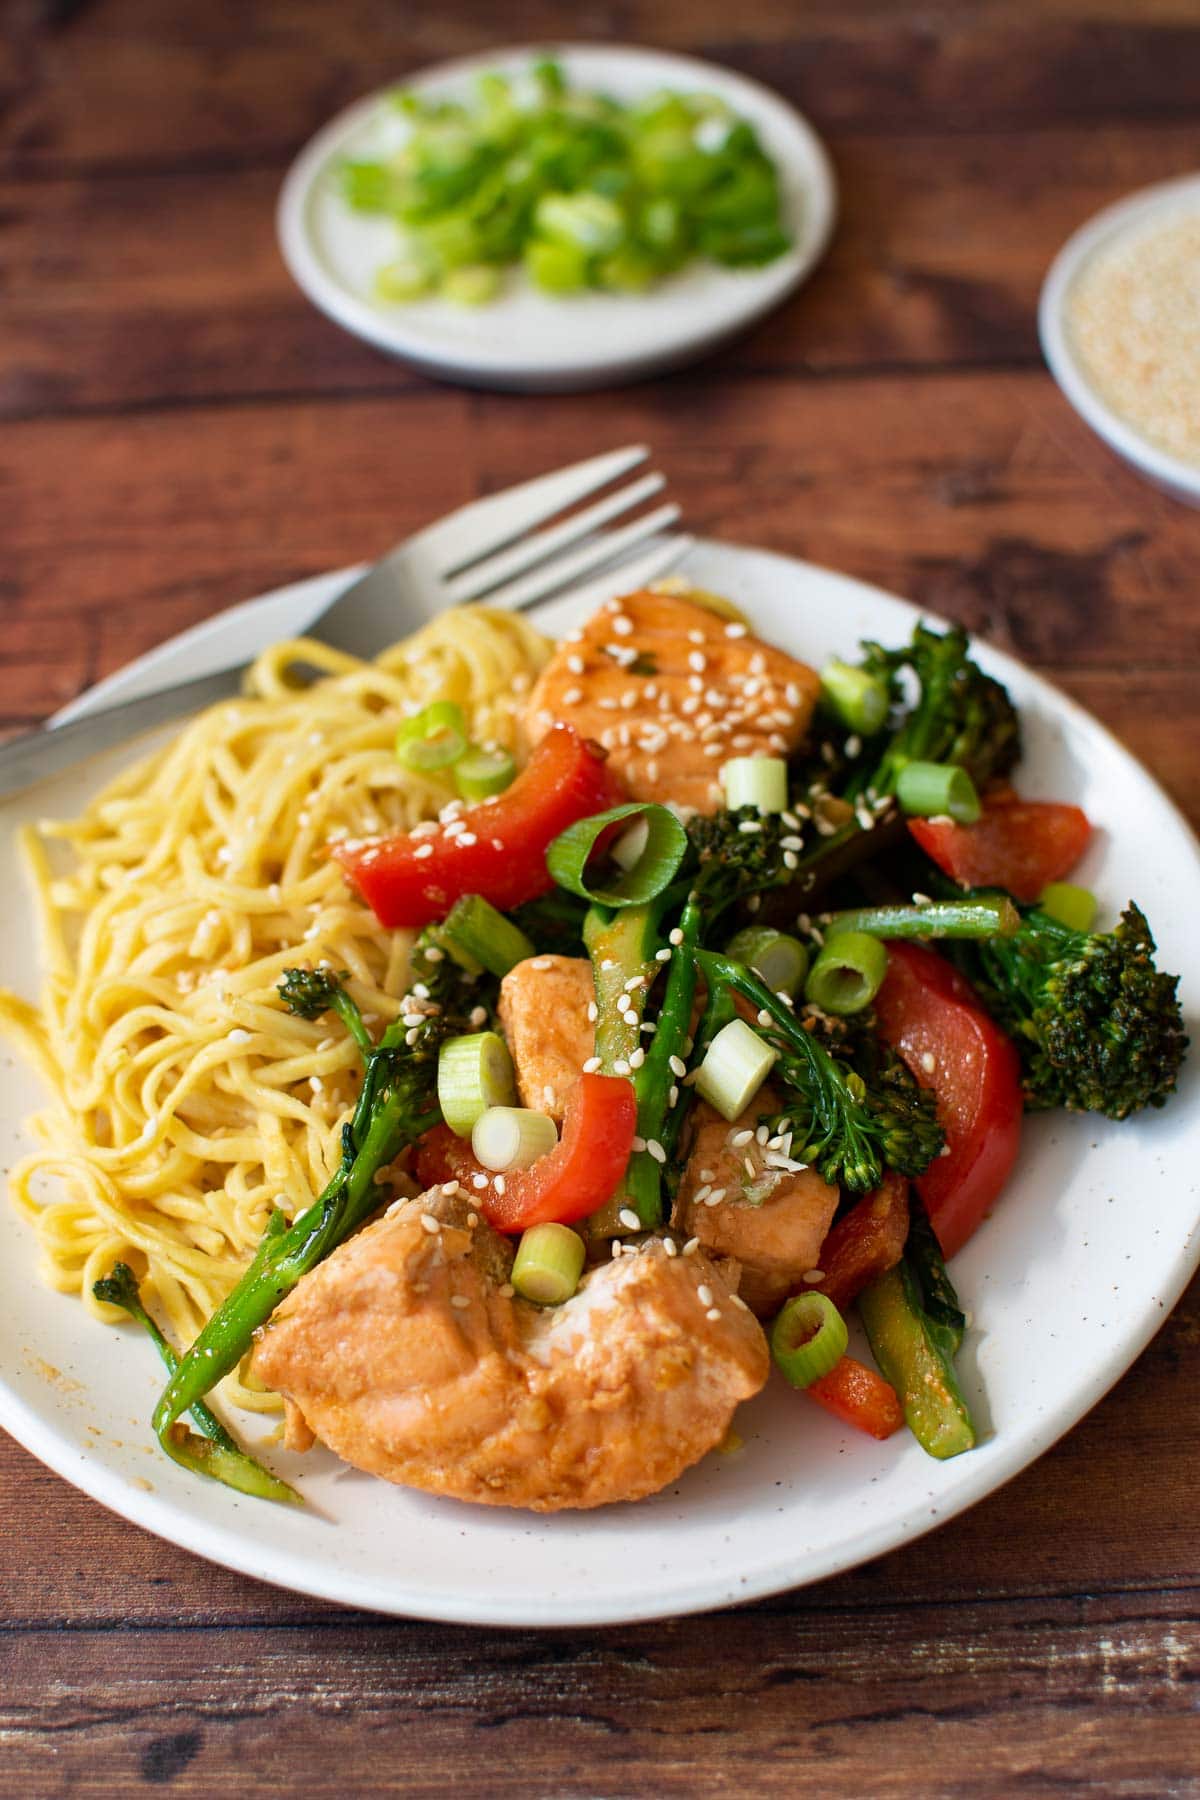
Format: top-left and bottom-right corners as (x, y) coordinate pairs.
(909, 794), (1092, 902)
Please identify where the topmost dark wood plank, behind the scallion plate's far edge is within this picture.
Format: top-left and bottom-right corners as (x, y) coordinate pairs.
(0, 0), (1200, 173)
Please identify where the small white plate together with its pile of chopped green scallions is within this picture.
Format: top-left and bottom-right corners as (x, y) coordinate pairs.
(279, 45), (835, 389)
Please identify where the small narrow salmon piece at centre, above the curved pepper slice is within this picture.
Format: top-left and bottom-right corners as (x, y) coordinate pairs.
(500, 956), (596, 1125)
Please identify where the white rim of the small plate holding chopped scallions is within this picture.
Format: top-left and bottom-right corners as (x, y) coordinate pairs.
(275, 43), (837, 391)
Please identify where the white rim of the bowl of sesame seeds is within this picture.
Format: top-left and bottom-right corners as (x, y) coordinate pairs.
(1038, 175), (1200, 506)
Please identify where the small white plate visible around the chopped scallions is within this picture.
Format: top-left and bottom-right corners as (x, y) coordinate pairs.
(277, 45), (837, 391)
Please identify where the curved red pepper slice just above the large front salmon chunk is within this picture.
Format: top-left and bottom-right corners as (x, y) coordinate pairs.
(417, 1075), (637, 1231)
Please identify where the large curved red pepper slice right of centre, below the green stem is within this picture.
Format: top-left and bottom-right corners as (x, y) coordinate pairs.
(874, 943), (1022, 1256)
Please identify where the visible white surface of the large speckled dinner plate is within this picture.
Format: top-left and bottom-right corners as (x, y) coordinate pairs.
(0, 544), (1200, 1625)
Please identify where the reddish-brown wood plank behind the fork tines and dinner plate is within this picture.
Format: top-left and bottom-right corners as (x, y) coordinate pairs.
(0, 373), (1200, 712)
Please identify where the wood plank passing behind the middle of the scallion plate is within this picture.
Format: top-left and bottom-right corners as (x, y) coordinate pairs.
(0, 126), (1198, 416)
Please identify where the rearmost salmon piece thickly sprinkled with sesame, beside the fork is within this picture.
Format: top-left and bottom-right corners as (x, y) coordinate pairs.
(525, 592), (820, 812)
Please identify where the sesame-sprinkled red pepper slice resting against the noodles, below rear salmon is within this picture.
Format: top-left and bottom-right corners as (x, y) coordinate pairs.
(333, 725), (626, 927)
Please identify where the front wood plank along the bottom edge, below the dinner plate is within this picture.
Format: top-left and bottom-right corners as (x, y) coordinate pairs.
(0, 1589), (1200, 1800)
